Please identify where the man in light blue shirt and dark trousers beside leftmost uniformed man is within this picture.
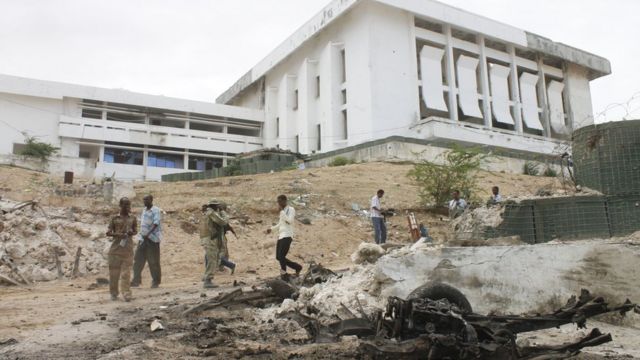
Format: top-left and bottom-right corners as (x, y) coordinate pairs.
(131, 195), (162, 288)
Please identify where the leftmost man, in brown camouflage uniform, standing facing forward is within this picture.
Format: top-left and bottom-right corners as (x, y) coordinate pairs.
(107, 197), (138, 301)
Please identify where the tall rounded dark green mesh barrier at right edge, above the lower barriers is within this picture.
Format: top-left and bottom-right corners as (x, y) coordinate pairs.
(573, 120), (640, 195)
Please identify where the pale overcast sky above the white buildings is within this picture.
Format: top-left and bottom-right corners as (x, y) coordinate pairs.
(0, 0), (640, 119)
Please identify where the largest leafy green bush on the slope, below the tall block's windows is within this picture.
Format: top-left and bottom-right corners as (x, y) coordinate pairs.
(407, 146), (489, 206)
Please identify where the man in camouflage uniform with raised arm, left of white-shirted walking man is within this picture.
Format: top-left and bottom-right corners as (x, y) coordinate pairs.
(200, 200), (229, 289)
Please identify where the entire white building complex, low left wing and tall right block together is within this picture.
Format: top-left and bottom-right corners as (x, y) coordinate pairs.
(0, 0), (611, 180)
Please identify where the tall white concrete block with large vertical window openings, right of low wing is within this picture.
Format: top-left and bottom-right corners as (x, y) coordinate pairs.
(217, 0), (611, 158)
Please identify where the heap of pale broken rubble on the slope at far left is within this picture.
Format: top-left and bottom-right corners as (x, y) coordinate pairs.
(0, 200), (109, 282)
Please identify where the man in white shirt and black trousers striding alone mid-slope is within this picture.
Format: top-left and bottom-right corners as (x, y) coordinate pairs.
(267, 195), (302, 275)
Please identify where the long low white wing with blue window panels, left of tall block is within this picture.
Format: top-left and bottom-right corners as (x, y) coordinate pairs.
(0, 75), (264, 180)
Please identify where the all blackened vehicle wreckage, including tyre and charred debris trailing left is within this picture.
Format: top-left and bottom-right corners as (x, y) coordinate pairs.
(183, 265), (640, 360)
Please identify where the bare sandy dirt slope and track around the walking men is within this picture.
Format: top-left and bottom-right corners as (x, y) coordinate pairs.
(0, 163), (636, 359)
